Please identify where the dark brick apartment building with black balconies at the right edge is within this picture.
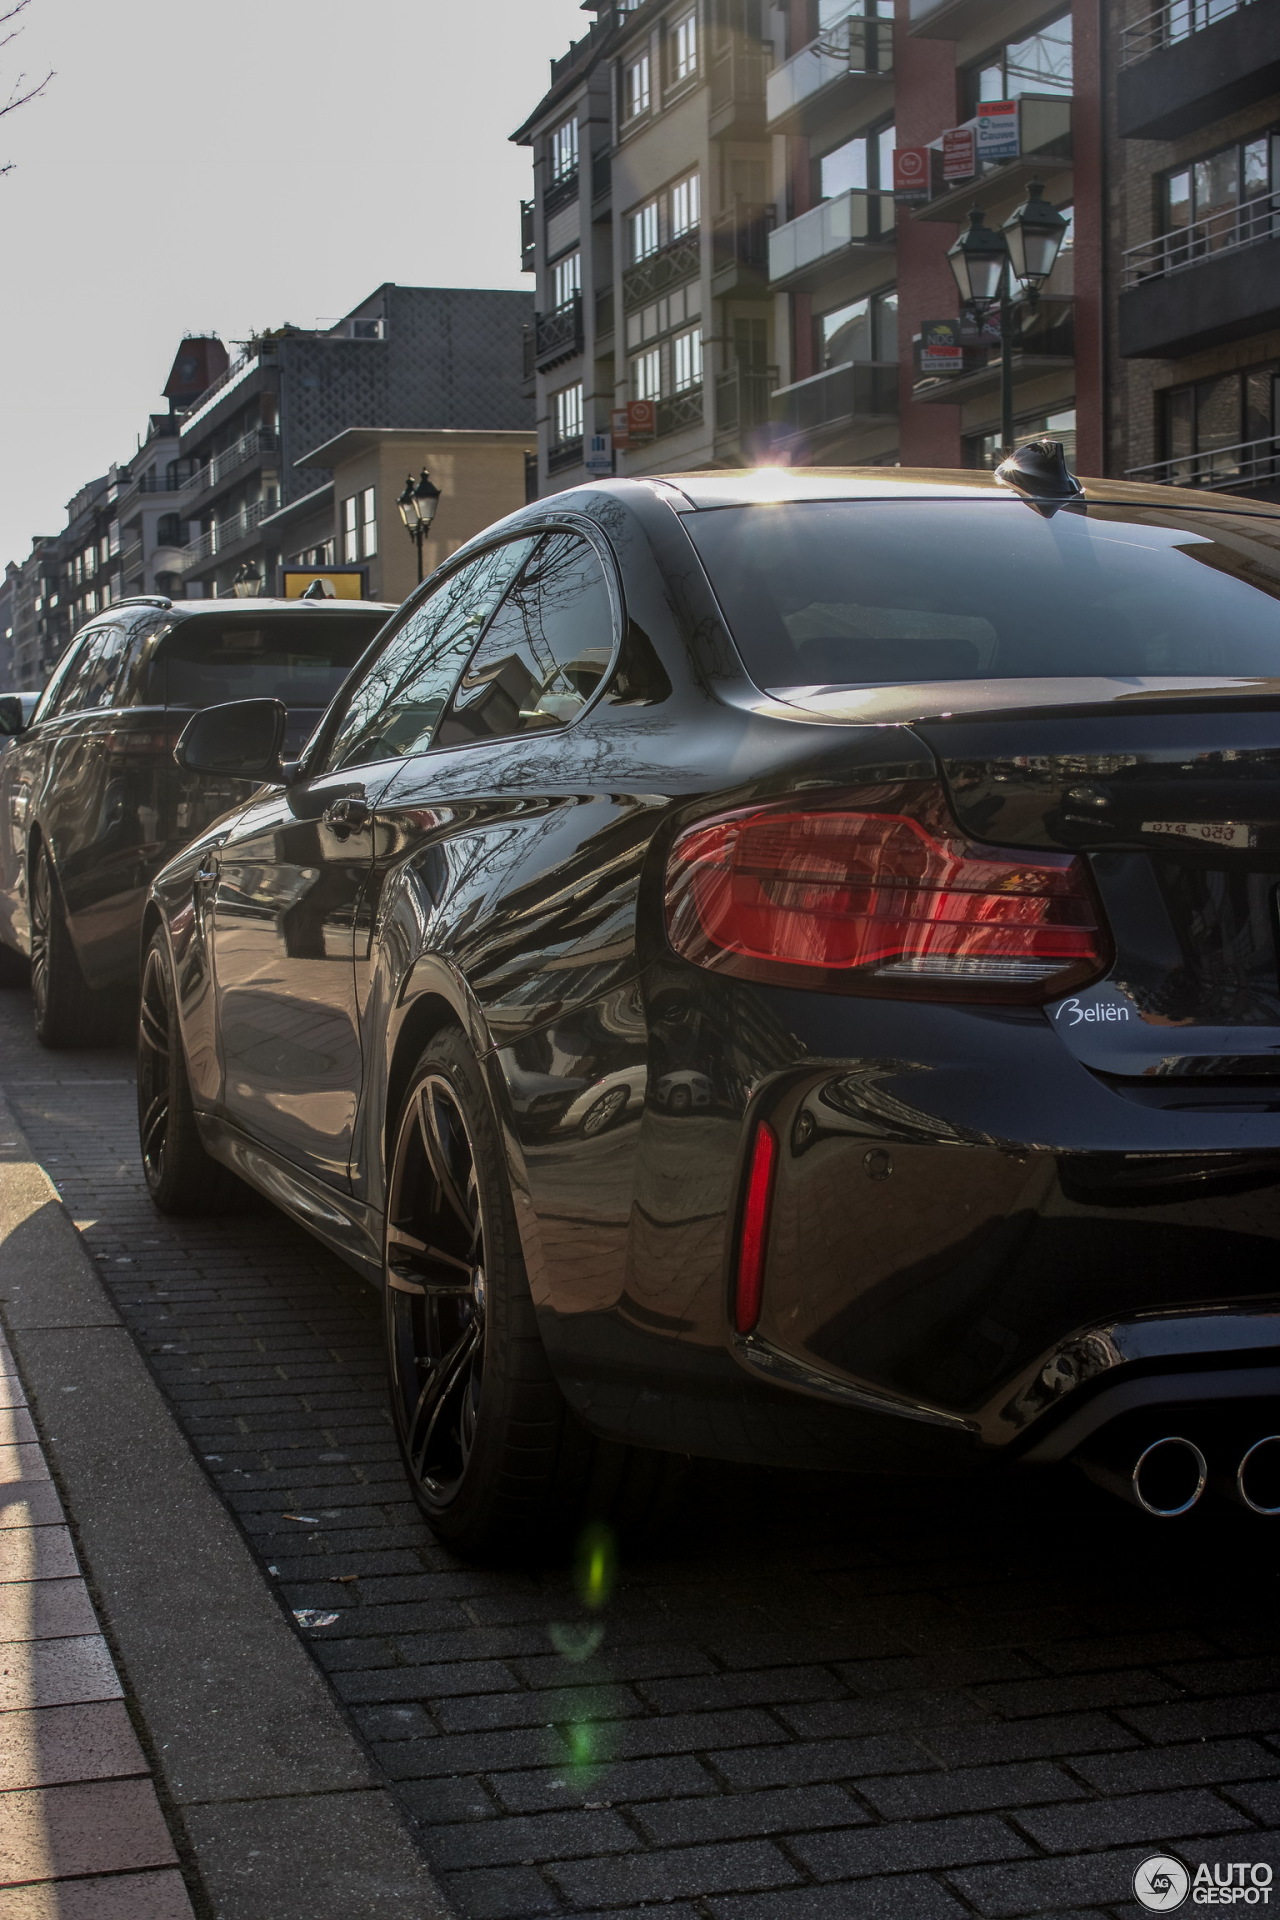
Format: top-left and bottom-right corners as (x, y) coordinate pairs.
(1107, 0), (1280, 499)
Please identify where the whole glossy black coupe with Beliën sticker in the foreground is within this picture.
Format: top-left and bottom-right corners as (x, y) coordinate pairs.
(138, 445), (1280, 1555)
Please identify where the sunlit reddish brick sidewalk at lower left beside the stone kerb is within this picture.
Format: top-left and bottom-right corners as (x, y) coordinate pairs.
(0, 1334), (192, 1920)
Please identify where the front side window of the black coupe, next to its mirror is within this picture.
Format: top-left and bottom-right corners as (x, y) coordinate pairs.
(324, 540), (533, 768)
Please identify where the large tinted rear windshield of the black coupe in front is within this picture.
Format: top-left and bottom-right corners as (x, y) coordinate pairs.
(683, 499), (1280, 689)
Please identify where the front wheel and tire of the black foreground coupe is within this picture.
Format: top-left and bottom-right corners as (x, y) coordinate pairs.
(138, 927), (246, 1213)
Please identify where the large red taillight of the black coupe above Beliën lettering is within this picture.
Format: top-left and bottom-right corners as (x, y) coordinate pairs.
(666, 781), (1109, 1002)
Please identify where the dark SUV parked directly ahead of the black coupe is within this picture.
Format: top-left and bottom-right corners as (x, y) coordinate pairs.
(0, 597), (391, 1046)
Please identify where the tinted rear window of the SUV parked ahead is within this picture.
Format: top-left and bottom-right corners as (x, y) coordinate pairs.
(155, 612), (386, 707)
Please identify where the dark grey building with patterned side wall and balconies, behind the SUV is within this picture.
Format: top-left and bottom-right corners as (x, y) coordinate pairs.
(175, 284), (532, 597)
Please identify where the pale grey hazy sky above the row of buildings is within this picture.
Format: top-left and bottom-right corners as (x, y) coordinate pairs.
(0, 0), (589, 566)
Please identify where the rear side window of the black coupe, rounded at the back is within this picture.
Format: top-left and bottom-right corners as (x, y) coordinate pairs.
(438, 534), (614, 747)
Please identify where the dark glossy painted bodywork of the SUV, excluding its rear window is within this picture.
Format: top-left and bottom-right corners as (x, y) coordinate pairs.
(0, 601), (390, 989)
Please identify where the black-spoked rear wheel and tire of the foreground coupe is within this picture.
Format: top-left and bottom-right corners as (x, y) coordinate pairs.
(384, 1027), (687, 1563)
